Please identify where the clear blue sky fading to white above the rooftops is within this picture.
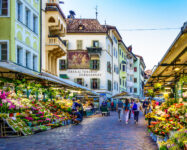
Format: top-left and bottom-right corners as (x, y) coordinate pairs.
(61, 0), (187, 69)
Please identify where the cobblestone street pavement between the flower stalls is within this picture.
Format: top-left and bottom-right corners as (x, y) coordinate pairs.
(0, 112), (157, 150)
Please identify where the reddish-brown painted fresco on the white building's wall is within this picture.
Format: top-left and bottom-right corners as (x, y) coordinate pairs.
(68, 51), (90, 69)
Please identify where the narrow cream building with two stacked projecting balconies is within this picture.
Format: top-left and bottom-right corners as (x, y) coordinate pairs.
(42, 0), (67, 76)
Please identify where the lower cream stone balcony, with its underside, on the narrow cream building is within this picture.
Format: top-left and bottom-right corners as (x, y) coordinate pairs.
(46, 37), (67, 57)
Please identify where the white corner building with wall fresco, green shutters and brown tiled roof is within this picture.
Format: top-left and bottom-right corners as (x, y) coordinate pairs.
(58, 18), (122, 97)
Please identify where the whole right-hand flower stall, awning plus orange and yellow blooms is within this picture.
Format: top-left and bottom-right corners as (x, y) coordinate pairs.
(144, 24), (187, 150)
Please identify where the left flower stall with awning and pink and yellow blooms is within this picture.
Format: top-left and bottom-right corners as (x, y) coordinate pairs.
(0, 62), (96, 137)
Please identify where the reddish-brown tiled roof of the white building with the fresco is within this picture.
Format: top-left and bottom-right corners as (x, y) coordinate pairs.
(66, 18), (107, 33)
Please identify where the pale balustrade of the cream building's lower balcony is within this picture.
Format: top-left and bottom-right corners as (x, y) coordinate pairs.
(47, 36), (67, 53)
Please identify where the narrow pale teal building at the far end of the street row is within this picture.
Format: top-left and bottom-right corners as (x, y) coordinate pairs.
(134, 55), (146, 98)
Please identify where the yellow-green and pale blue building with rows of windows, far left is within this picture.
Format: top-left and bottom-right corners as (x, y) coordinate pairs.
(0, 0), (41, 72)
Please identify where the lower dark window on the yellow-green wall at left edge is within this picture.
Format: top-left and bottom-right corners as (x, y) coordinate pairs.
(0, 42), (8, 61)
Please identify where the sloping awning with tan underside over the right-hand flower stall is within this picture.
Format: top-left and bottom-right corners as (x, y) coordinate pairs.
(144, 22), (187, 91)
